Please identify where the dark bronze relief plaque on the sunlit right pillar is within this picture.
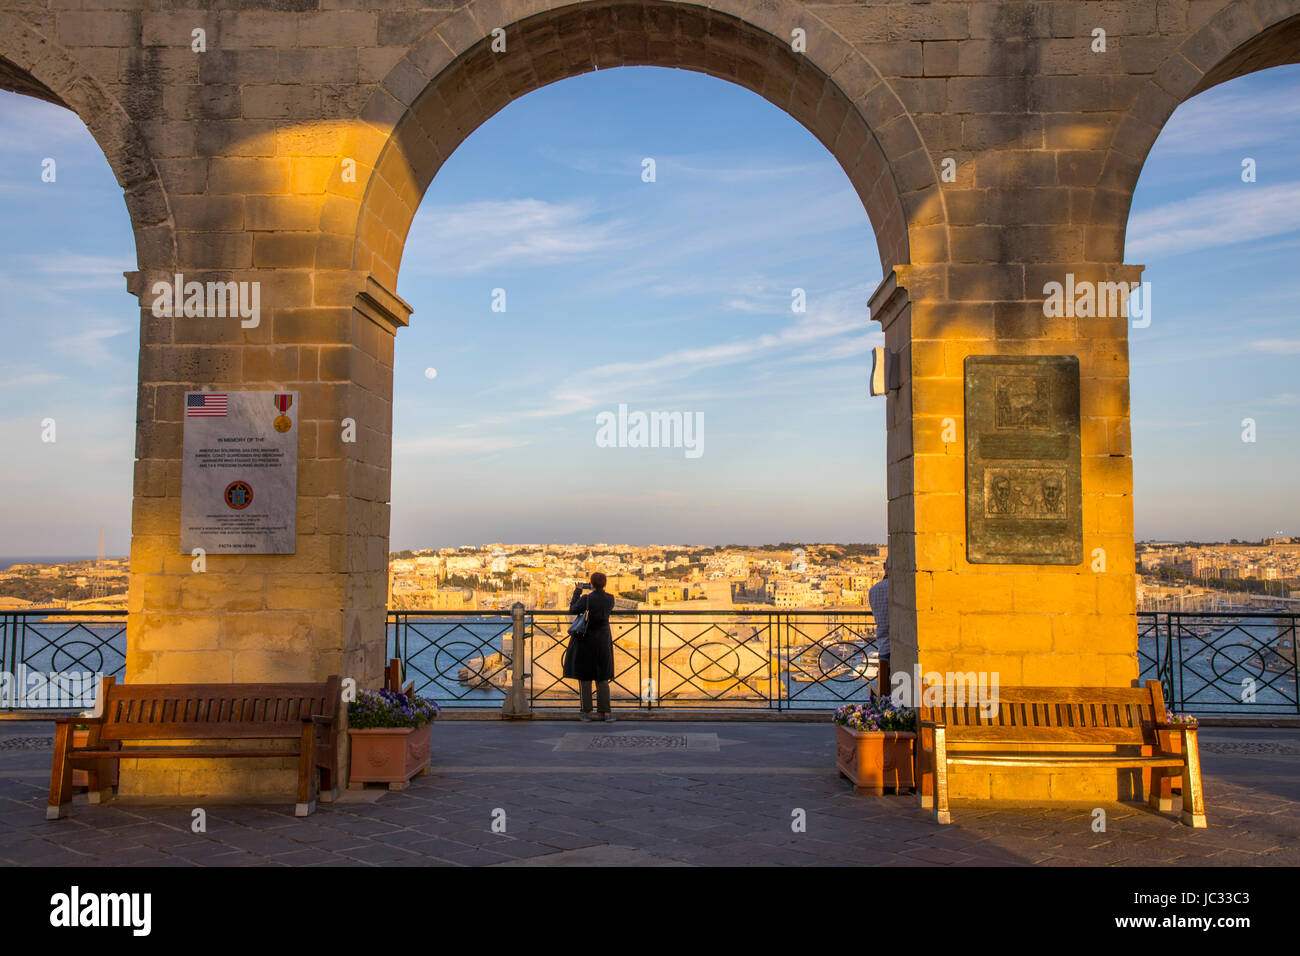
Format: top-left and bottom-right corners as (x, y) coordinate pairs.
(966, 355), (1083, 564)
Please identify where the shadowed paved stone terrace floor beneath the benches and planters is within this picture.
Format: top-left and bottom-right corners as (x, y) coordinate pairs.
(0, 719), (1300, 866)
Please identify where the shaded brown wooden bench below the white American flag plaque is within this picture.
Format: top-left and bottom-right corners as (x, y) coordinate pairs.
(46, 676), (341, 819)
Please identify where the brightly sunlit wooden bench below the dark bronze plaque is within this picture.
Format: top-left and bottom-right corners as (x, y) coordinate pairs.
(917, 680), (1205, 827)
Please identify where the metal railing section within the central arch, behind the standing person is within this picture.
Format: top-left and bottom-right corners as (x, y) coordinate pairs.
(389, 610), (876, 710)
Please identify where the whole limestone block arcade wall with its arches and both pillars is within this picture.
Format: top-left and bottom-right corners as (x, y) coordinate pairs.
(0, 0), (1300, 796)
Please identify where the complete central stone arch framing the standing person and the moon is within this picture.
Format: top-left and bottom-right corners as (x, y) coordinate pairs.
(335, 0), (946, 287)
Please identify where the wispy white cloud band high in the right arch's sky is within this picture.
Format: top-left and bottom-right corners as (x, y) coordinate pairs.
(1125, 182), (1300, 261)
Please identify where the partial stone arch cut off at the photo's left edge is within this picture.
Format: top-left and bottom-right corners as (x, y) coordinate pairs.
(0, 13), (177, 273)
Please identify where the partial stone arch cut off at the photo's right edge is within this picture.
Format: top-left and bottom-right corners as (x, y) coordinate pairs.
(1093, 0), (1300, 261)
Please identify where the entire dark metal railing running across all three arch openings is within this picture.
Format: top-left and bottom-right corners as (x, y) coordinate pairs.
(0, 609), (1300, 717)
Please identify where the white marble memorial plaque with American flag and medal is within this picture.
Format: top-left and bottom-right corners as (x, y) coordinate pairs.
(181, 392), (298, 554)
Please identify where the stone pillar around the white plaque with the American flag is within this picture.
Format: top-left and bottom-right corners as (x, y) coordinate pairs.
(121, 261), (411, 799)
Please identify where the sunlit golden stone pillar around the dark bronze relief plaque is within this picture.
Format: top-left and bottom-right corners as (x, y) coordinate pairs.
(871, 263), (1140, 801)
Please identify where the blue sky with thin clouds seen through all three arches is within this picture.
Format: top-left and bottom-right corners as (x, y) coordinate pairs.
(0, 66), (1300, 555)
